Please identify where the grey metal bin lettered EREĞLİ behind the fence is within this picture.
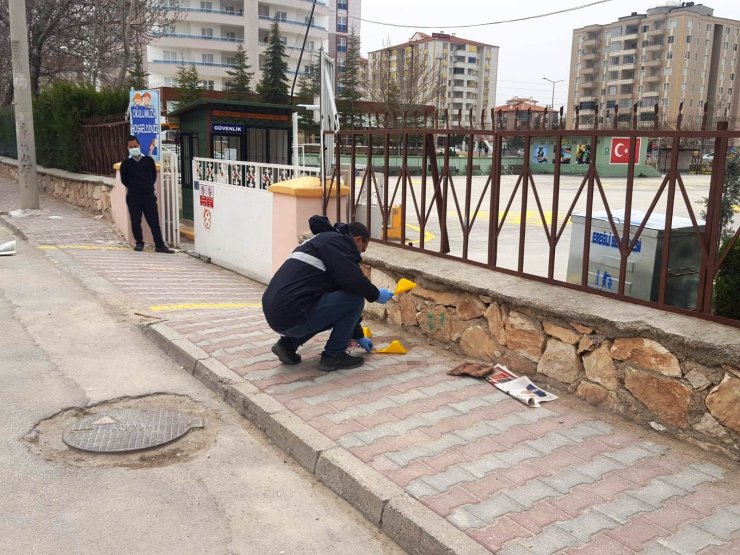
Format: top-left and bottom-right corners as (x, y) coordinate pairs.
(566, 210), (704, 309)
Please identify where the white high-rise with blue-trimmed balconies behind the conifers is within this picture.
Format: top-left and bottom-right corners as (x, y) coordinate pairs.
(145, 0), (361, 94)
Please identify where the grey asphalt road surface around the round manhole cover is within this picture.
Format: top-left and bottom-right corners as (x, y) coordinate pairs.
(0, 227), (401, 555)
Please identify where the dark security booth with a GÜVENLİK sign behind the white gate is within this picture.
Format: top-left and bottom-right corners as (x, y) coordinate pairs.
(168, 98), (297, 220)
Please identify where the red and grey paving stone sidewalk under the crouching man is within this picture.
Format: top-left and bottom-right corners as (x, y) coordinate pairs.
(0, 178), (740, 554)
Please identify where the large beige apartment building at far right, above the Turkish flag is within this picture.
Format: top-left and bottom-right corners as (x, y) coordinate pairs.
(568, 2), (740, 129)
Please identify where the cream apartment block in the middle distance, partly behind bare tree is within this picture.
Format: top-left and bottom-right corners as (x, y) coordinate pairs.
(369, 32), (499, 118)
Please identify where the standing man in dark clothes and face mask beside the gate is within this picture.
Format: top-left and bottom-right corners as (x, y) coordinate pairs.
(120, 135), (175, 254)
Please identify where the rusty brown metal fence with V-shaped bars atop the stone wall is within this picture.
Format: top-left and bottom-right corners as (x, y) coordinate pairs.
(324, 106), (740, 326)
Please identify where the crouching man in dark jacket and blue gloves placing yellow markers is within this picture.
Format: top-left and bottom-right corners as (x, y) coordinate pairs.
(262, 216), (393, 372)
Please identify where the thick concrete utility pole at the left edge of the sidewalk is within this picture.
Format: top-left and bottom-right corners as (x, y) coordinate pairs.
(8, 0), (39, 210)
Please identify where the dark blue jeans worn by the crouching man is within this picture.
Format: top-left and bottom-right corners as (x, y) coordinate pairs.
(280, 291), (365, 356)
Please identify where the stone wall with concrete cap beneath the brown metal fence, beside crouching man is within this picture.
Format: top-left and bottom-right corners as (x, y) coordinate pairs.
(366, 245), (740, 460)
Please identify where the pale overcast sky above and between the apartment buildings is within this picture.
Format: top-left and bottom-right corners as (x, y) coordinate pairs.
(360, 0), (740, 107)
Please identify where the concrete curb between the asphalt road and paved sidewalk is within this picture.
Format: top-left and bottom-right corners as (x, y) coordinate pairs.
(144, 322), (490, 555)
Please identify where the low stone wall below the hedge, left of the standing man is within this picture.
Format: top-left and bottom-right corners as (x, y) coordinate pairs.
(0, 158), (115, 221)
